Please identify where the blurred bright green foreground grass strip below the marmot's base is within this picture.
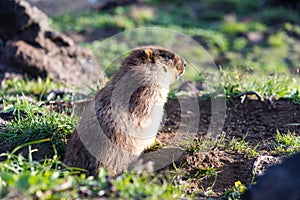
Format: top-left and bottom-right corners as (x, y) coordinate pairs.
(0, 145), (184, 199)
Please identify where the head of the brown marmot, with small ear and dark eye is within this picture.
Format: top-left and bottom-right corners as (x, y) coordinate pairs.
(122, 46), (186, 79)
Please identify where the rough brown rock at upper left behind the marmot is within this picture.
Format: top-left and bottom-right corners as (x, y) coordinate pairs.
(0, 0), (105, 91)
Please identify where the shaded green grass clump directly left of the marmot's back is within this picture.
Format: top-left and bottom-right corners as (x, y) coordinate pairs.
(0, 100), (78, 154)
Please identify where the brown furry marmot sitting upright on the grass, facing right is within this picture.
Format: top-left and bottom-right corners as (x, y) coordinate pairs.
(64, 46), (186, 175)
